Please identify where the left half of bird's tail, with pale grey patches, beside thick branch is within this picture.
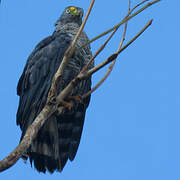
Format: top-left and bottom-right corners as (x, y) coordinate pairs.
(28, 116), (62, 173)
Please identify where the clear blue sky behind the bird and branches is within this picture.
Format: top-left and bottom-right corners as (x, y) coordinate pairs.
(0, 0), (180, 180)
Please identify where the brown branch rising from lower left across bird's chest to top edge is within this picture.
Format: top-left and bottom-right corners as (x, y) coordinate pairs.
(0, 0), (95, 172)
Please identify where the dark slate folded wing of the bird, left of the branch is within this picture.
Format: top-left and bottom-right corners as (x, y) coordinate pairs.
(17, 33), (70, 135)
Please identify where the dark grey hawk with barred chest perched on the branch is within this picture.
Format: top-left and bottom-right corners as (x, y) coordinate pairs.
(16, 6), (94, 173)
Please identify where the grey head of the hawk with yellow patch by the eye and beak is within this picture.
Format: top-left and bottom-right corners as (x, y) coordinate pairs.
(55, 6), (84, 26)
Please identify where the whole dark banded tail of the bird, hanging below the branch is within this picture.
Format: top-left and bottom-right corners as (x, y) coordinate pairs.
(24, 108), (85, 173)
